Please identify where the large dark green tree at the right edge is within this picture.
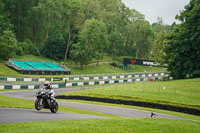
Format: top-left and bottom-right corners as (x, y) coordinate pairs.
(165, 0), (200, 79)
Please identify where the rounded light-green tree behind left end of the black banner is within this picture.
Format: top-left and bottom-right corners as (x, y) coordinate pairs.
(126, 20), (154, 59)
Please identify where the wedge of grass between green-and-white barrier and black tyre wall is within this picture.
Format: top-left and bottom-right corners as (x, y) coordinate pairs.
(64, 78), (200, 109)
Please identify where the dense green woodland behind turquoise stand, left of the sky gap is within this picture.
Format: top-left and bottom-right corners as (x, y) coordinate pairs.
(0, 0), (154, 65)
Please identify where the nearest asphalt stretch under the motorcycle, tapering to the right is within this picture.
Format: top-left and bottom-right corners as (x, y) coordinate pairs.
(0, 108), (106, 124)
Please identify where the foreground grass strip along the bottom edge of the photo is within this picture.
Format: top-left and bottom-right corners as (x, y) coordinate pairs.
(0, 118), (200, 133)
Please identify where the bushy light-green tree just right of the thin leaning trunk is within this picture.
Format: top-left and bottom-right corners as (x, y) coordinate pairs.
(71, 18), (107, 67)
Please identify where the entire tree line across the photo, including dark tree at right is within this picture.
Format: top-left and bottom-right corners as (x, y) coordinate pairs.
(0, 0), (200, 78)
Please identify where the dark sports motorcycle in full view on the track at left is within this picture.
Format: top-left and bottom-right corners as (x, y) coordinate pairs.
(35, 88), (58, 113)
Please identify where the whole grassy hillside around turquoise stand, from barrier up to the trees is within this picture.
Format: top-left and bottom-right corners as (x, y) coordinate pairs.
(0, 55), (166, 77)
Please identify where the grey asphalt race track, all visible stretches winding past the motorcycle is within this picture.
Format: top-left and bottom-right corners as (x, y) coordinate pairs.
(0, 88), (189, 124)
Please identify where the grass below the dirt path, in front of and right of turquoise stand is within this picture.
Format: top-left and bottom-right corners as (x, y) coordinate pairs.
(0, 64), (166, 77)
